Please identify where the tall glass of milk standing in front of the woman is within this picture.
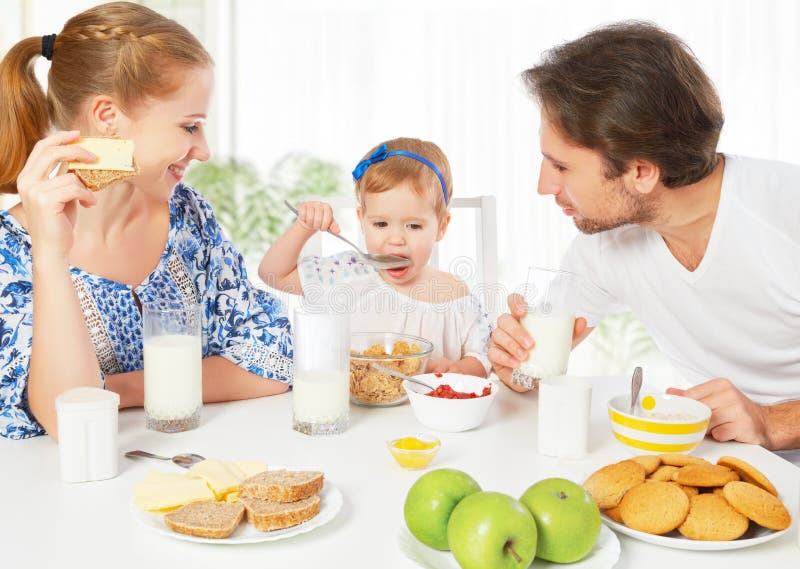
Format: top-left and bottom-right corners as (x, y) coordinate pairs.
(142, 300), (203, 433)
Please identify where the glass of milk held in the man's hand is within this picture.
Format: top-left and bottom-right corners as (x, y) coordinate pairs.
(511, 267), (578, 388)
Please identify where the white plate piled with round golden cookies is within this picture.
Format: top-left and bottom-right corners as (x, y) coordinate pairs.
(583, 454), (792, 551)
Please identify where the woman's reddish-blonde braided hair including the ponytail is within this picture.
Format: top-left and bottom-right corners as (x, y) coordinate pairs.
(0, 2), (213, 193)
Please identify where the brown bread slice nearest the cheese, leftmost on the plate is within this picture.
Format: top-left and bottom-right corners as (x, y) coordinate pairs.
(164, 502), (244, 539)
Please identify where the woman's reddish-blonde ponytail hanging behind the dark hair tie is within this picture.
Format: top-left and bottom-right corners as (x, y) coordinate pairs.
(0, 36), (50, 194)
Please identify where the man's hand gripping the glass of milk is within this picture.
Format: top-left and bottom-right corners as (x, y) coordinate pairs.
(488, 294), (592, 391)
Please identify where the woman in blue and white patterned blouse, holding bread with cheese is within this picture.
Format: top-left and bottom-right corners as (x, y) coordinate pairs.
(0, 2), (292, 439)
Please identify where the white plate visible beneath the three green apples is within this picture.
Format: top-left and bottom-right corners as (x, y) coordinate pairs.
(397, 524), (620, 569)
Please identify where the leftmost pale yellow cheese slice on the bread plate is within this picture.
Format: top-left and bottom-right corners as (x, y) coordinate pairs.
(134, 472), (215, 511)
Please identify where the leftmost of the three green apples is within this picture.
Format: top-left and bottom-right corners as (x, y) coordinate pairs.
(403, 468), (481, 550)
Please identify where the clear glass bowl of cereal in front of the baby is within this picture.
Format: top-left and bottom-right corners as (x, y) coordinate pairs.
(350, 332), (433, 407)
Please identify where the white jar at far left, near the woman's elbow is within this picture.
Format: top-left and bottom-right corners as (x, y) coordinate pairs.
(56, 387), (119, 482)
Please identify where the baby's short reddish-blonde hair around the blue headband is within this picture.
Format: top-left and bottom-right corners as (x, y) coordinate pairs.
(355, 138), (453, 220)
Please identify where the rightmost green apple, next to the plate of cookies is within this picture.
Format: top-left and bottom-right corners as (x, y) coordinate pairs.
(519, 478), (600, 563)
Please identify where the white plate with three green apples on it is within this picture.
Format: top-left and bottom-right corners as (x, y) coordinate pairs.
(397, 468), (620, 569)
